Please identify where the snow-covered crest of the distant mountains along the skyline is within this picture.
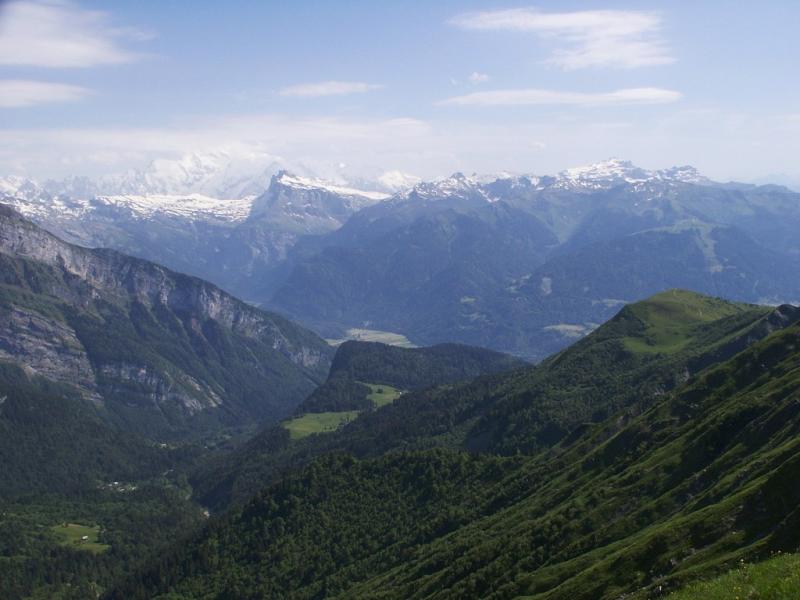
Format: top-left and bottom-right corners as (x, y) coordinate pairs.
(0, 159), (724, 234)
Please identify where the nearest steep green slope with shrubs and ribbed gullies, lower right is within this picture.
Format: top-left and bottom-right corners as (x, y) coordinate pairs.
(109, 298), (800, 600)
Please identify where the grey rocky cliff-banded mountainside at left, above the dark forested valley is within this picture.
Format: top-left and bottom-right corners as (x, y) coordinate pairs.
(0, 207), (332, 437)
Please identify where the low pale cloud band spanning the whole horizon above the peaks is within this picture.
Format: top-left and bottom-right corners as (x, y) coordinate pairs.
(0, 107), (800, 181)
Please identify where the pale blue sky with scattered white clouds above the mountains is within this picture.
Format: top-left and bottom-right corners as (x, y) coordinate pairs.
(0, 0), (800, 185)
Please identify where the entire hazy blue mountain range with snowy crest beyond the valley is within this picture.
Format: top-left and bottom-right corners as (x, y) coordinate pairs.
(3, 159), (800, 360)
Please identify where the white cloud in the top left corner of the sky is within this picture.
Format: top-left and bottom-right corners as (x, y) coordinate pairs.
(0, 0), (151, 68)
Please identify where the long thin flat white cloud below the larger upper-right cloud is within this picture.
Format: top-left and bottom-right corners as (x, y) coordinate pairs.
(438, 88), (683, 106)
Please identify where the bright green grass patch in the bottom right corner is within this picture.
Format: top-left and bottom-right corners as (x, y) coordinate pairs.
(667, 554), (800, 600)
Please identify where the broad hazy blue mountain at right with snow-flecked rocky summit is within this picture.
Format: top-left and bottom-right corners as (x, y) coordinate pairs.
(270, 160), (800, 358)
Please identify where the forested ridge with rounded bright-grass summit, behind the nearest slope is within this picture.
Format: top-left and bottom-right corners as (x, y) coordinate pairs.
(193, 290), (798, 509)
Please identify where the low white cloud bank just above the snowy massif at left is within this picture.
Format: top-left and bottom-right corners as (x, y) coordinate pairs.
(0, 114), (431, 177)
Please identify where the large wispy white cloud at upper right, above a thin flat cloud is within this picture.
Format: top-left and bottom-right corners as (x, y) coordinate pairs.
(450, 8), (674, 70)
